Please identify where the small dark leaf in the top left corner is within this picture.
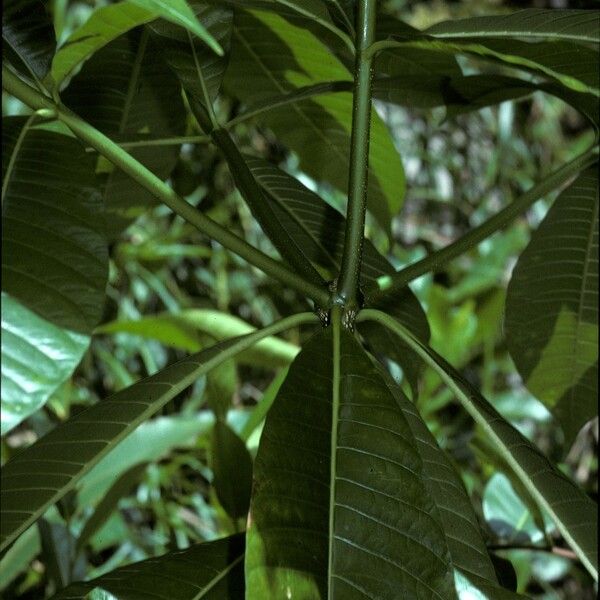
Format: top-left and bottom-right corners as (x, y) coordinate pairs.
(2, 0), (56, 80)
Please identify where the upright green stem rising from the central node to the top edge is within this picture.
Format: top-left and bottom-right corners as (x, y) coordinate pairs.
(337, 0), (376, 310)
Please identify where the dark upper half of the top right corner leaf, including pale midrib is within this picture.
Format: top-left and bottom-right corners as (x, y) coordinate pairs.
(425, 8), (600, 43)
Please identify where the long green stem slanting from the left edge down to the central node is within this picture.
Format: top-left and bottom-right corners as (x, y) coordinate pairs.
(2, 65), (329, 305)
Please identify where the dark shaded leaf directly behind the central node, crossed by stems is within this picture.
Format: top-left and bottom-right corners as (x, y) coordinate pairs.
(247, 157), (429, 394)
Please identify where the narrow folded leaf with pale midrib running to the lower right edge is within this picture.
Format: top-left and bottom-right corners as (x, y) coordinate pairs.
(359, 309), (598, 578)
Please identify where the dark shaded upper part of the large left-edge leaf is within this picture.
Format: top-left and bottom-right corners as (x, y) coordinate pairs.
(2, 117), (108, 334)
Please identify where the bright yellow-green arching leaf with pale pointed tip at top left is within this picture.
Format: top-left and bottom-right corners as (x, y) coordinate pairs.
(51, 0), (223, 85)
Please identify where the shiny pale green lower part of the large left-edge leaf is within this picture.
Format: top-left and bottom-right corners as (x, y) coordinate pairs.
(1, 292), (90, 435)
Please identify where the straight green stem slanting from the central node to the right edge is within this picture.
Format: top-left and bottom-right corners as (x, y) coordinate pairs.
(367, 147), (598, 306)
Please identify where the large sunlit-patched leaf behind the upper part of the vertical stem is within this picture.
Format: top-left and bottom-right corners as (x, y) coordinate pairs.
(225, 10), (404, 228)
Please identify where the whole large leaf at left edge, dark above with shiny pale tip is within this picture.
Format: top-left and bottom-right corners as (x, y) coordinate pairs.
(1, 117), (108, 434)
